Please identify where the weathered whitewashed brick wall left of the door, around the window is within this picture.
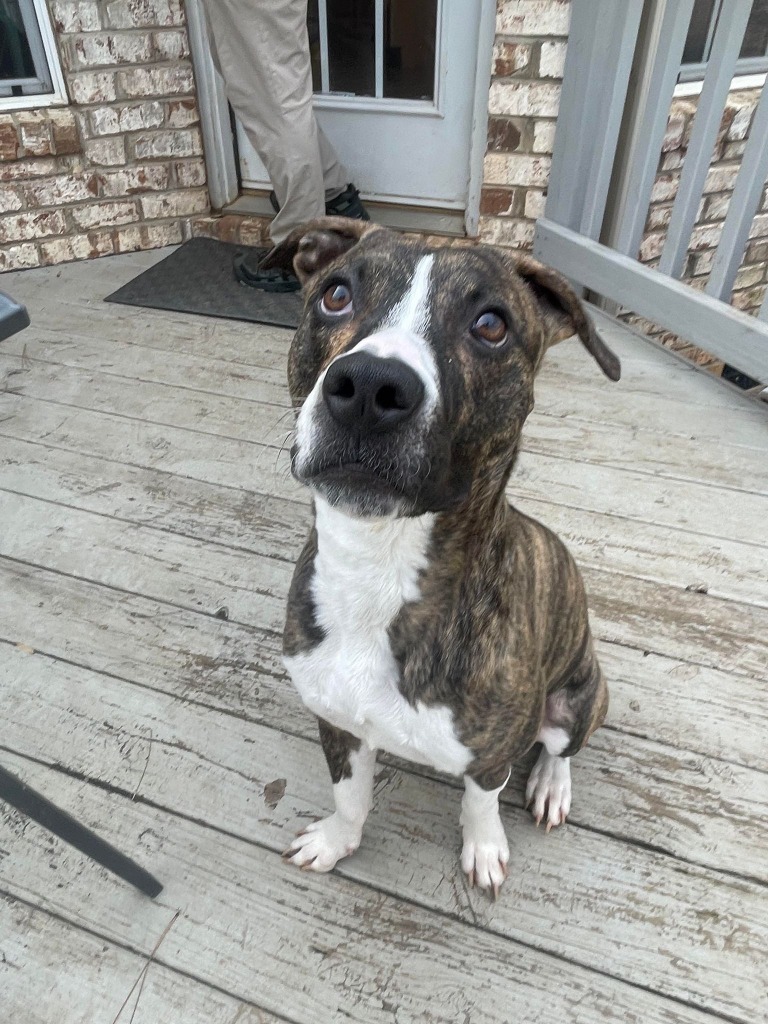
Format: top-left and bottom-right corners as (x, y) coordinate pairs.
(0, 0), (209, 270)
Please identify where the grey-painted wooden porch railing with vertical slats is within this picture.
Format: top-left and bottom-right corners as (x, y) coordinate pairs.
(534, 0), (768, 383)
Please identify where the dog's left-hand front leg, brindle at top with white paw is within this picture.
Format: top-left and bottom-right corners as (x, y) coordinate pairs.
(284, 719), (376, 871)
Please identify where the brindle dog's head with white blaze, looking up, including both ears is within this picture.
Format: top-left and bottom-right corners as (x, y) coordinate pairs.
(263, 217), (620, 515)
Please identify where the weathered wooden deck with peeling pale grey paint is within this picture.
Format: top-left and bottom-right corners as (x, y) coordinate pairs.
(0, 253), (768, 1024)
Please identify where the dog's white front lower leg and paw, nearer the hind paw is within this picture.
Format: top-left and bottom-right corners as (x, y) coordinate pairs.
(459, 773), (509, 899)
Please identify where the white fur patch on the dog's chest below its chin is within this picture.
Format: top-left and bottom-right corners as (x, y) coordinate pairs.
(286, 499), (472, 774)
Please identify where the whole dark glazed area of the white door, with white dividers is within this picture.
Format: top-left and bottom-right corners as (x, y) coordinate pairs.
(307, 0), (438, 100)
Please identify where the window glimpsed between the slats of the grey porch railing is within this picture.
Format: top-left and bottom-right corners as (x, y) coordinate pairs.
(680, 0), (768, 82)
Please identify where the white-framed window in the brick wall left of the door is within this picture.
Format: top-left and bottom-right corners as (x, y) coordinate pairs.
(0, 0), (67, 110)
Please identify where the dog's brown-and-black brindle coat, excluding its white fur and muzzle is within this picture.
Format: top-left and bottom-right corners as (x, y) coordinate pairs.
(269, 219), (618, 788)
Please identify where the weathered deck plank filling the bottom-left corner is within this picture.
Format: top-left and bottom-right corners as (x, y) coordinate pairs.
(0, 897), (274, 1024)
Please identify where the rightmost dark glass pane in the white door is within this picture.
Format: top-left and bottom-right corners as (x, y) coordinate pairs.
(384, 0), (437, 99)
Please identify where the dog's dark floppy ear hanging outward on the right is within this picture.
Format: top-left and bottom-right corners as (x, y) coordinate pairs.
(514, 255), (622, 381)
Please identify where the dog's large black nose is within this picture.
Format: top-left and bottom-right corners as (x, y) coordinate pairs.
(323, 352), (424, 434)
